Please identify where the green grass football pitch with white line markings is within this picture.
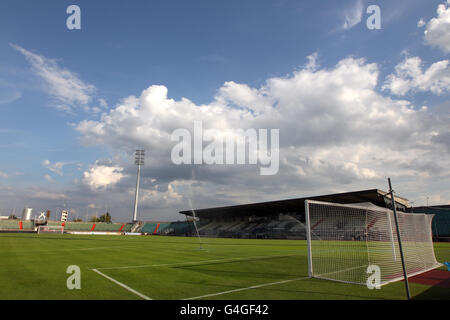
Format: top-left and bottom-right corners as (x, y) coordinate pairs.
(0, 233), (450, 300)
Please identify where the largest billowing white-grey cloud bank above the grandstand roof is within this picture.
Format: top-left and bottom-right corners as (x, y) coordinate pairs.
(76, 56), (450, 215)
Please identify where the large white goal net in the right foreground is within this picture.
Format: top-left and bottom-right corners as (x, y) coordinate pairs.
(305, 200), (441, 285)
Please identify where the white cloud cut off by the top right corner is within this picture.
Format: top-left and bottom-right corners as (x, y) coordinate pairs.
(424, 1), (450, 53)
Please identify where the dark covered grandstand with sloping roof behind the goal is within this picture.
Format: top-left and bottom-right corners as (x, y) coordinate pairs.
(180, 189), (410, 239)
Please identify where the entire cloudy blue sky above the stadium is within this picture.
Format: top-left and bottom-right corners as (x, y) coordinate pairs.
(0, 0), (450, 222)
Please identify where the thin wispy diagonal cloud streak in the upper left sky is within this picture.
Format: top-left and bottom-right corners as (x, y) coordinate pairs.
(11, 44), (95, 112)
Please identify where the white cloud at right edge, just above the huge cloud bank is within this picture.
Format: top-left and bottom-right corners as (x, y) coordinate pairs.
(383, 57), (450, 96)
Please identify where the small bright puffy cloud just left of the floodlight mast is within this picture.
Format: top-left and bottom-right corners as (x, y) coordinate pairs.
(82, 162), (124, 190)
